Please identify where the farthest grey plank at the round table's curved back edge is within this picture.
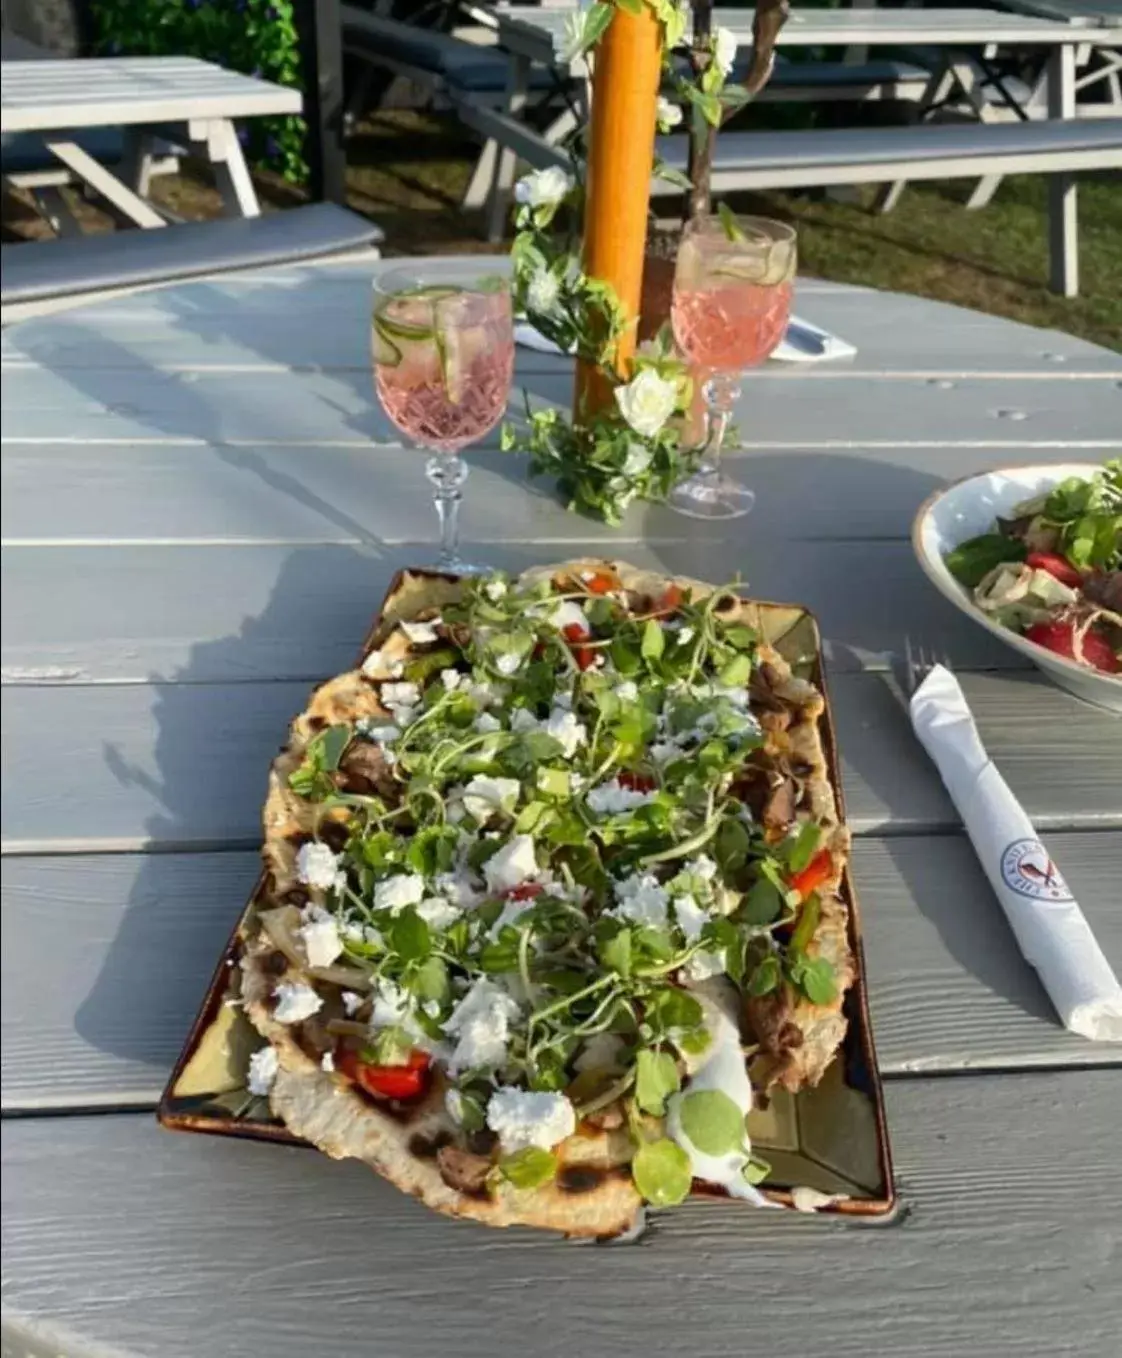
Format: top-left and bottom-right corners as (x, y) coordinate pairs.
(0, 267), (1122, 380)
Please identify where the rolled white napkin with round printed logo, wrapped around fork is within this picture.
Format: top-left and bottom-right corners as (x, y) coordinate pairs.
(911, 665), (1122, 1042)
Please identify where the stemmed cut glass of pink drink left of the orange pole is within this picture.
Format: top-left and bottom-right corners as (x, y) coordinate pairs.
(372, 259), (515, 574)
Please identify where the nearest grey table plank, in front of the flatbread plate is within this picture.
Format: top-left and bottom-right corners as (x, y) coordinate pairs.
(3, 1070), (1122, 1358)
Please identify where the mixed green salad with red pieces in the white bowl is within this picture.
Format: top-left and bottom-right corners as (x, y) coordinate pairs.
(945, 459), (1122, 675)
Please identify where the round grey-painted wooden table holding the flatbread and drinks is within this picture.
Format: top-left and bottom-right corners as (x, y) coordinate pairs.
(3, 256), (1122, 1358)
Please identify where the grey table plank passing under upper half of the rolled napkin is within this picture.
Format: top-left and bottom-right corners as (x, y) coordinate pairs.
(3, 674), (1122, 853)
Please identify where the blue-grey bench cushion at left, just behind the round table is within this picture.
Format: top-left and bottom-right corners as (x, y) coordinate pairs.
(0, 202), (382, 304)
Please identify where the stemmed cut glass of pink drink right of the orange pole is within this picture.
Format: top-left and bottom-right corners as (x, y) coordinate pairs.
(670, 212), (796, 519)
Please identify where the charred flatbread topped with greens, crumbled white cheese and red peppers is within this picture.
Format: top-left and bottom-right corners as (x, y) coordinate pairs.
(242, 561), (854, 1237)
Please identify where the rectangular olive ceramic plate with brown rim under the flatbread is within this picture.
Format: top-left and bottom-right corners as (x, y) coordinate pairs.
(158, 570), (895, 1218)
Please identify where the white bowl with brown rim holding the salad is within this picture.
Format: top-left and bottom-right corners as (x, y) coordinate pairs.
(911, 462), (1122, 713)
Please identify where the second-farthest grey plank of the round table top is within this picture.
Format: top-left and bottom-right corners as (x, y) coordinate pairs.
(8, 361), (1122, 448)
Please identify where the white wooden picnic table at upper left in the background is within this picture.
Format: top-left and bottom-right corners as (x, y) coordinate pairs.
(0, 57), (302, 228)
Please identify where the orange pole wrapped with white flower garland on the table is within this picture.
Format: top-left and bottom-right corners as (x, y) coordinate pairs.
(576, 5), (662, 411)
